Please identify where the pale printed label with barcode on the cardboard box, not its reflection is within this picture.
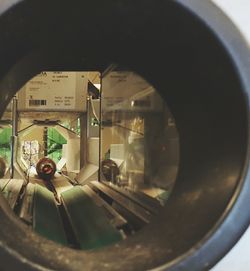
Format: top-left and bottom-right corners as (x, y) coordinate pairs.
(25, 72), (76, 110)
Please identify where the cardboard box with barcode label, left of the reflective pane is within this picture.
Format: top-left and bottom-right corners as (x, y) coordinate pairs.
(18, 72), (88, 112)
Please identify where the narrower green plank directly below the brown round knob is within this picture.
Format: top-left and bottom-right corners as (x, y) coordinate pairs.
(33, 184), (67, 245)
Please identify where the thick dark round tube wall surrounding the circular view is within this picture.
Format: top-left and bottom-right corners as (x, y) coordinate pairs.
(1, 1), (249, 270)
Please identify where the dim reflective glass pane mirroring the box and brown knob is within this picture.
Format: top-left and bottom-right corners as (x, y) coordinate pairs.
(100, 71), (179, 205)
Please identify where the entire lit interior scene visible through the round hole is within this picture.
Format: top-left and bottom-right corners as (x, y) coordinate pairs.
(0, 67), (179, 250)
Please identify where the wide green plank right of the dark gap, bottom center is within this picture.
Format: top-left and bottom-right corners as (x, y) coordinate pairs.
(61, 186), (122, 250)
